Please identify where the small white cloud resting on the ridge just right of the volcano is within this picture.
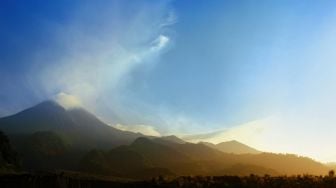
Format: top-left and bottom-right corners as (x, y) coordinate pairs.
(114, 124), (161, 136)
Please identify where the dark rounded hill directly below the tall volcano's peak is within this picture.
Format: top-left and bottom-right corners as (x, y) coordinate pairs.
(13, 131), (85, 170)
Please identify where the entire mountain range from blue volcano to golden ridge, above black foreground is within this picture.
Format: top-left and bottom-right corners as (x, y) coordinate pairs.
(0, 101), (328, 178)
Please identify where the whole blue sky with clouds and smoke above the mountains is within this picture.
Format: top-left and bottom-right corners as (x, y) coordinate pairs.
(0, 0), (336, 162)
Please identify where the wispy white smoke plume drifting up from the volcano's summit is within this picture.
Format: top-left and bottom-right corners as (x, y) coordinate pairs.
(27, 2), (177, 117)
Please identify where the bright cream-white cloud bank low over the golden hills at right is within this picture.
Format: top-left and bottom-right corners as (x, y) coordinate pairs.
(179, 114), (336, 162)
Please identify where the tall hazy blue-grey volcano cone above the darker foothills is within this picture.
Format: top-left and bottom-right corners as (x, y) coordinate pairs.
(0, 101), (142, 149)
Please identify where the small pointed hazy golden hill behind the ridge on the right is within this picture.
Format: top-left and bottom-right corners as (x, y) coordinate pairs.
(201, 140), (261, 154)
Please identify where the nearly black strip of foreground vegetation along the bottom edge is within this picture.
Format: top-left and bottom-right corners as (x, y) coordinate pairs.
(0, 172), (336, 188)
